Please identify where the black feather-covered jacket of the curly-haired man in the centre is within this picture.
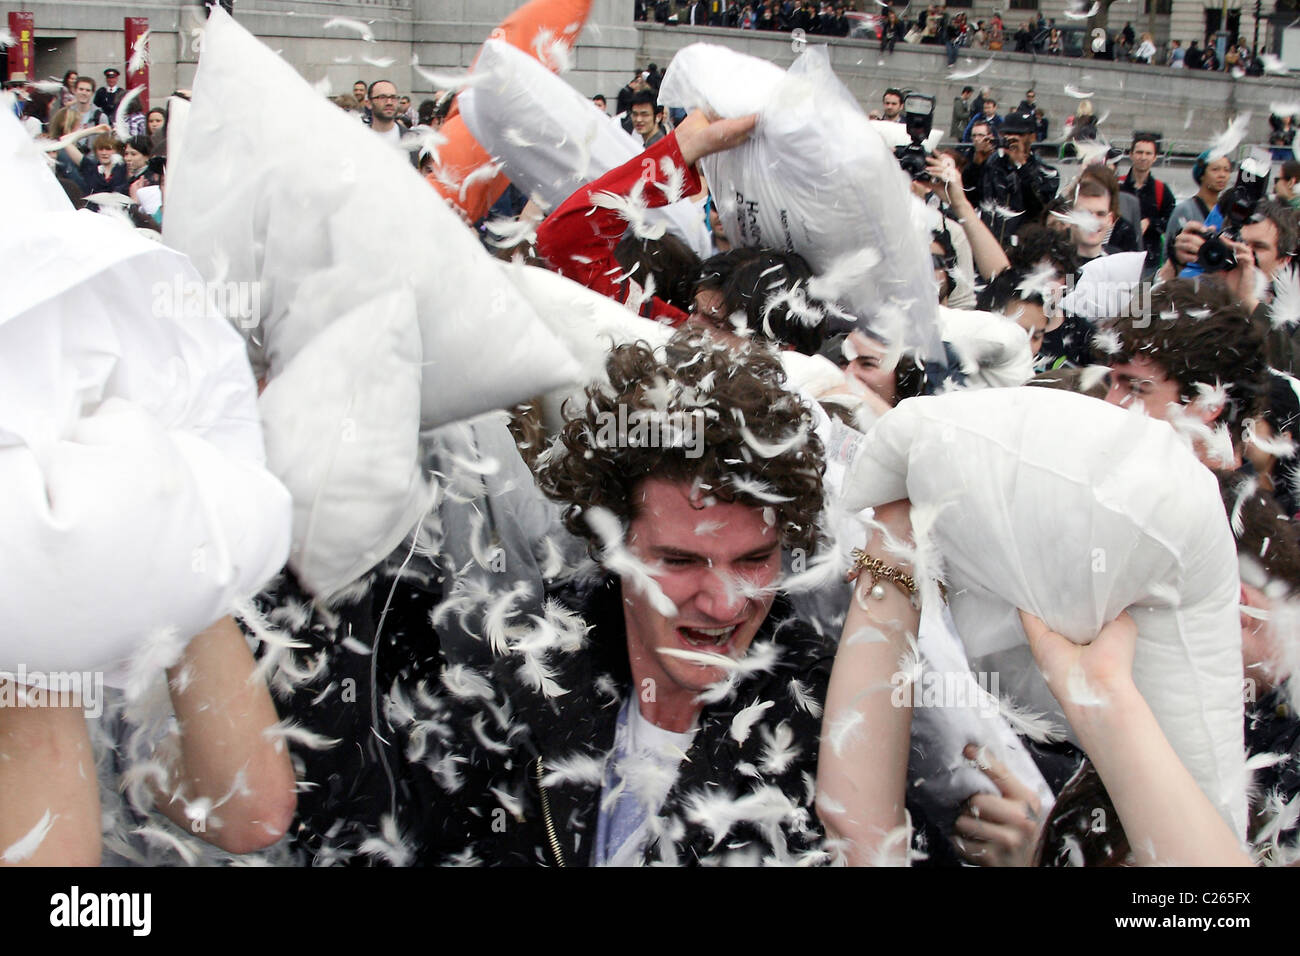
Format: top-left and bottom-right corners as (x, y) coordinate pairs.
(424, 579), (835, 866)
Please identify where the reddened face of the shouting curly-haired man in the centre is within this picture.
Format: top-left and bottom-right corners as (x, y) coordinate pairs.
(623, 477), (781, 711)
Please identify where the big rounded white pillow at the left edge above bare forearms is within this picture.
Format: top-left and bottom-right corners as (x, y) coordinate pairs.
(0, 201), (290, 687)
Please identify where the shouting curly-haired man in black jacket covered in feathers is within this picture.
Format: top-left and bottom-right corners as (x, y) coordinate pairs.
(420, 326), (833, 865)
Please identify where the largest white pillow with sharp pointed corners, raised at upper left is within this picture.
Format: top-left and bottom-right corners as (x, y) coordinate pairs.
(164, 9), (576, 427)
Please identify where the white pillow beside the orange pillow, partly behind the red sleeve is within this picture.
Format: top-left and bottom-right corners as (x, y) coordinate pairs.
(458, 40), (712, 259)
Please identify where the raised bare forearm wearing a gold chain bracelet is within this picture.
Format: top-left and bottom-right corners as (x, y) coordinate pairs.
(816, 501), (920, 866)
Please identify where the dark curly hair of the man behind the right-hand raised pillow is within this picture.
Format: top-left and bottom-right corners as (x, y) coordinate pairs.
(1106, 278), (1269, 440)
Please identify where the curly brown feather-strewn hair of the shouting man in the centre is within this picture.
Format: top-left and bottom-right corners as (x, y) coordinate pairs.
(536, 326), (826, 551)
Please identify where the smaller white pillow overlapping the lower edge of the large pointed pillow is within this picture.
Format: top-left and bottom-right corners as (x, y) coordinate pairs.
(260, 290), (432, 598)
